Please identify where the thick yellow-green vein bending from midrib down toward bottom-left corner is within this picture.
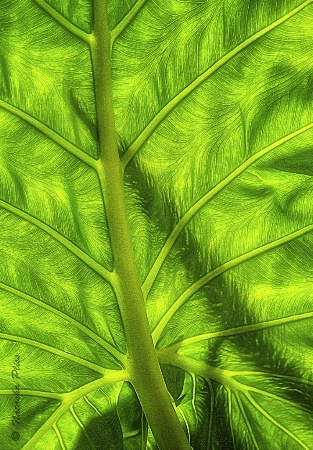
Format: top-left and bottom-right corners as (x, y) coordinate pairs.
(21, 370), (127, 450)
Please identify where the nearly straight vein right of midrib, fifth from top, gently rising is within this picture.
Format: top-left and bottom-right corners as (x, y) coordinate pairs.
(162, 312), (313, 354)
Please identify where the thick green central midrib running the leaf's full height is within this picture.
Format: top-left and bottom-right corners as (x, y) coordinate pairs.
(91, 0), (190, 450)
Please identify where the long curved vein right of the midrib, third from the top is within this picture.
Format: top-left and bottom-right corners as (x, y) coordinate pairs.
(142, 122), (313, 298)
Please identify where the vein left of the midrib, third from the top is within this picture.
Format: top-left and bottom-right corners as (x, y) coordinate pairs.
(0, 200), (115, 285)
